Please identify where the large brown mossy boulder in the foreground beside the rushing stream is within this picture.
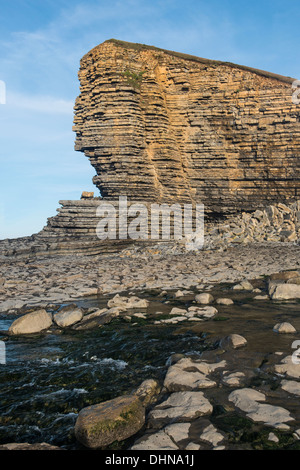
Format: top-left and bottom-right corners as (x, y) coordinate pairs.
(75, 395), (145, 449)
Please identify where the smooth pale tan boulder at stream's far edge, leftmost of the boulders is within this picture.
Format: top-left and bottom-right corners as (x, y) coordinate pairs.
(8, 309), (52, 335)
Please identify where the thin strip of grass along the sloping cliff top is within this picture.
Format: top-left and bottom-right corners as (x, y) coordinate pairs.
(101, 39), (295, 83)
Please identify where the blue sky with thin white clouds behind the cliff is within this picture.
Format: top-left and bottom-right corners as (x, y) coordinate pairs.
(0, 0), (300, 239)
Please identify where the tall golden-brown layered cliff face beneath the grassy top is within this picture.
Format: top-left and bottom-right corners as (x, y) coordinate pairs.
(74, 40), (300, 215)
